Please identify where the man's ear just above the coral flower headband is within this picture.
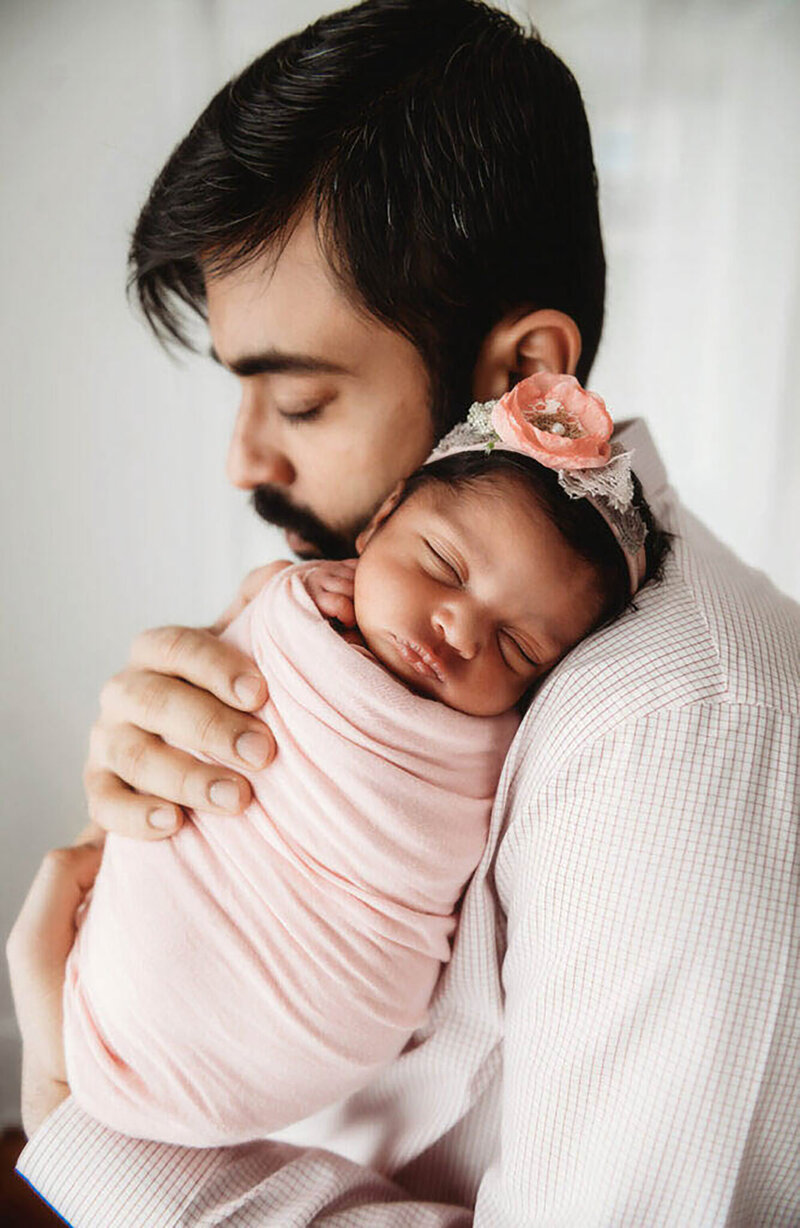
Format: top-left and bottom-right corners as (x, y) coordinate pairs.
(472, 307), (581, 400)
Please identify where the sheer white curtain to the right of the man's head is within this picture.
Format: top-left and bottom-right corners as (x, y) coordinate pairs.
(528, 0), (800, 598)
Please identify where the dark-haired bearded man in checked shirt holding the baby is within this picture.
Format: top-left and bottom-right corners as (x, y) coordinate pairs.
(11, 0), (800, 1228)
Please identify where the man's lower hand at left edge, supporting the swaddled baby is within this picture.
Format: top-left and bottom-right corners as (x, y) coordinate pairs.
(6, 842), (102, 1137)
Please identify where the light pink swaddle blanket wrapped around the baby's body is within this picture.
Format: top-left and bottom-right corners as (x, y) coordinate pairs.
(64, 564), (517, 1147)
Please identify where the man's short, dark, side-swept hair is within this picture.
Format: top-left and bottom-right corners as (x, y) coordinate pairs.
(129, 0), (605, 430)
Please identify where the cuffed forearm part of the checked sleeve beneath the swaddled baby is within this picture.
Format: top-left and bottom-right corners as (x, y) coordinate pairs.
(17, 1097), (472, 1228)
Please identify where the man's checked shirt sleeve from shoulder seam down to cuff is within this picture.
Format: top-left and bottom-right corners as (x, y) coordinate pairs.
(15, 705), (800, 1228)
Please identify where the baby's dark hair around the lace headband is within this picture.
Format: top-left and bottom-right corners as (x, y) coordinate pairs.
(398, 449), (670, 630)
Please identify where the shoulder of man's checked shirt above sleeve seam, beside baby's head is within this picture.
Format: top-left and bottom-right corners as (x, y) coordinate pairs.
(515, 493), (800, 761)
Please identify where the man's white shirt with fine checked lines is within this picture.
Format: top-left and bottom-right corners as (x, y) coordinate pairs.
(20, 422), (800, 1228)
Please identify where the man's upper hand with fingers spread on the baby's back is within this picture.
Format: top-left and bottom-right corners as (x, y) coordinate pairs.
(84, 560), (290, 840)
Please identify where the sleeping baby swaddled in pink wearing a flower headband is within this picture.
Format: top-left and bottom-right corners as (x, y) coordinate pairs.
(64, 376), (664, 1147)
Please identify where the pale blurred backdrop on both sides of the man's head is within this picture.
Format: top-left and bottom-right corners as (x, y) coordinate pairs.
(0, 0), (800, 1121)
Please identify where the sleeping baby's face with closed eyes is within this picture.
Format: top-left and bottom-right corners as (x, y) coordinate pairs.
(355, 475), (602, 716)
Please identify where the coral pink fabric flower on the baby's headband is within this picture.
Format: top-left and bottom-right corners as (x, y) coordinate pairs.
(492, 372), (614, 469)
